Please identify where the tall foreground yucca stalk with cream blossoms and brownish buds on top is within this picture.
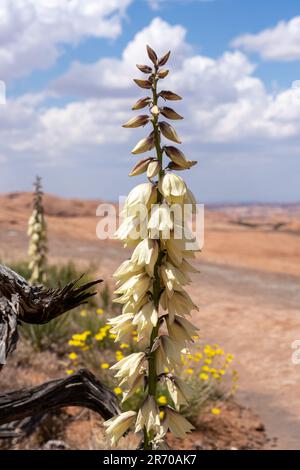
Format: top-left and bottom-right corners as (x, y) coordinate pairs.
(106, 46), (197, 449)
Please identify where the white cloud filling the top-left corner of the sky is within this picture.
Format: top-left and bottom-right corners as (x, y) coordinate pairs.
(0, 0), (132, 81)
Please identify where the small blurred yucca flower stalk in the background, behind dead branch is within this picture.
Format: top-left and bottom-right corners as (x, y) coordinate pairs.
(27, 176), (47, 284)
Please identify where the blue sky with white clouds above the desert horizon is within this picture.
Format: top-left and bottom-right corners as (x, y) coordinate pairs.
(0, 0), (300, 203)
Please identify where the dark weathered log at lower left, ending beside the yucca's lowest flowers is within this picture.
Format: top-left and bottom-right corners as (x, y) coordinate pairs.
(0, 369), (120, 425)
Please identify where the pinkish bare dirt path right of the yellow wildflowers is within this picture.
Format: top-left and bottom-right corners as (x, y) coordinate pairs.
(191, 263), (300, 449)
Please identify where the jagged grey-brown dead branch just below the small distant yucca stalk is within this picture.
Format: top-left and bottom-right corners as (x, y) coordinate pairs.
(0, 265), (101, 369)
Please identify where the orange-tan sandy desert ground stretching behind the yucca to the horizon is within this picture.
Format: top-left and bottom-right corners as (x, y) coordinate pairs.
(0, 193), (300, 449)
